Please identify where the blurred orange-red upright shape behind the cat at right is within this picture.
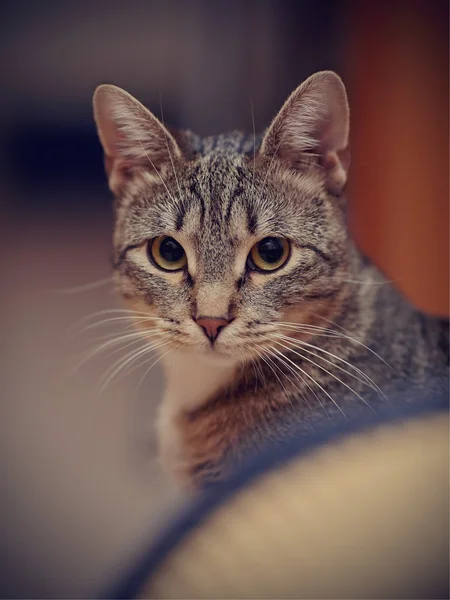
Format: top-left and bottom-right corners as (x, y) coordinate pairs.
(346, 0), (449, 315)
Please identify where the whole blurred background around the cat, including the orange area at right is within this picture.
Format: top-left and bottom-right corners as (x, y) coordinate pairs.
(0, 0), (449, 597)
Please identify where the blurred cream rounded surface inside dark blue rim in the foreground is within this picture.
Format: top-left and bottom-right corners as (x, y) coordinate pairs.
(139, 413), (449, 598)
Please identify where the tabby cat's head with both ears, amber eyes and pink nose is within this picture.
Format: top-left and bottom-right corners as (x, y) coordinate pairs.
(94, 72), (349, 361)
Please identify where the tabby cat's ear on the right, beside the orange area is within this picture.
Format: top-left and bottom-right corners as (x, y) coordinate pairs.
(260, 71), (350, 194)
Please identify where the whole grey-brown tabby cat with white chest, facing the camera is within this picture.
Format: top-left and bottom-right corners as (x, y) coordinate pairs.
(94, 71), (449, 488)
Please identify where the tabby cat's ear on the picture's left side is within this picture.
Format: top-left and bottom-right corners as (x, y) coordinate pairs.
(93, 85), (181, 194)
